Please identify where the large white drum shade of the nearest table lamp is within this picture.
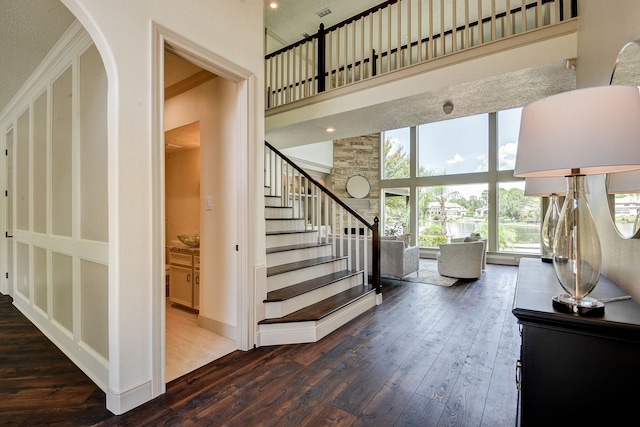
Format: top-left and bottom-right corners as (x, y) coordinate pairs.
(514, 86), (640, 178)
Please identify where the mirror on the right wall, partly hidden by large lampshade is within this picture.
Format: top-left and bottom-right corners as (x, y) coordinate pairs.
(606, 40), (640, 239)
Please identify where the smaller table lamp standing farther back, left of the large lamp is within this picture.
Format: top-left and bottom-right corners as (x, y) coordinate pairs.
(524, 176), (567, 263)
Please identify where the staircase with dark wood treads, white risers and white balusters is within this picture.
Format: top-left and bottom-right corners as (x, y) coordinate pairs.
(258, 142), (381, 345)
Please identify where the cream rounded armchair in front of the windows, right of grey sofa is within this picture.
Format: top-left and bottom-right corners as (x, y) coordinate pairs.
(436, 240), (485, 279)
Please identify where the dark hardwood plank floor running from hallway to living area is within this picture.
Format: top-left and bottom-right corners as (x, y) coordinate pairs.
(0, 261), (519, 427)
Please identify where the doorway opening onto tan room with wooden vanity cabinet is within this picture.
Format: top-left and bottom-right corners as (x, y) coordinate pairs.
(162, 50), (238, 382)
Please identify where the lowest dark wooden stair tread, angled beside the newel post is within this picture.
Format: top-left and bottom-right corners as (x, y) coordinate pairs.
(258, 285), (375, 325)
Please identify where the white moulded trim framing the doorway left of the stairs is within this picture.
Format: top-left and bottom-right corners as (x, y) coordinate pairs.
(151, 23), (257, 396)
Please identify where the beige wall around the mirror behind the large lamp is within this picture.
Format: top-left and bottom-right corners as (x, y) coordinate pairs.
(576, 0), (640, 300)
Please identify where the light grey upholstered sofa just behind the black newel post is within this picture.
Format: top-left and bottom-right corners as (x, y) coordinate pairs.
(344, 236), (420, 278)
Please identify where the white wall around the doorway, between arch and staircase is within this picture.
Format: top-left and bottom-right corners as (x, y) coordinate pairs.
(56, 0), (265, 413)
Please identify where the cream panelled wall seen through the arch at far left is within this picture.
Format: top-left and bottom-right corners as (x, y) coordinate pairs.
(0, 23), (110, 396)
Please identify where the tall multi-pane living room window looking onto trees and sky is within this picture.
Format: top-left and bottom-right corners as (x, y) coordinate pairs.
(380, 108), (541, 260)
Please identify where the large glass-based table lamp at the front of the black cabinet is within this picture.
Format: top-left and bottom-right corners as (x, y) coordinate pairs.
(514, 86), (640, 315)
